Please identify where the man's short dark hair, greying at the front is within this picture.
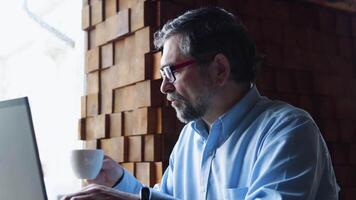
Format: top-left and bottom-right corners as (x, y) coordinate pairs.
(154, 7), (262, 83)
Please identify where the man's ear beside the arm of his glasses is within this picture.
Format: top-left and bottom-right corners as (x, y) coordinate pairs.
(210, 53), (230, 86)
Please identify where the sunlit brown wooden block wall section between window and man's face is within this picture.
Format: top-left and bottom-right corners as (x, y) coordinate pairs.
(78, 0), (183, 186)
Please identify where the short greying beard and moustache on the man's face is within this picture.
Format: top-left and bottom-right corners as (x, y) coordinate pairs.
(168, 91), (211, 123)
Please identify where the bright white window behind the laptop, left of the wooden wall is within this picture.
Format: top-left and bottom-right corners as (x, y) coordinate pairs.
(0, 0), (84, 200)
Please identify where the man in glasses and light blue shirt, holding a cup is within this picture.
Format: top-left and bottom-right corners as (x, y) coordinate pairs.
(63, 8), (339, 200)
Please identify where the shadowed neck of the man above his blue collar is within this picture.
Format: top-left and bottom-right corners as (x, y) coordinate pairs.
(202, 81), (250, 130)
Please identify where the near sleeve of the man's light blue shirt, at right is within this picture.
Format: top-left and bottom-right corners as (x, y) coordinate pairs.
(244, 117), (338, 200)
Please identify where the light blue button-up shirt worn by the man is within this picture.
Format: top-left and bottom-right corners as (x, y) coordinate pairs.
(116, 86), (340, 200)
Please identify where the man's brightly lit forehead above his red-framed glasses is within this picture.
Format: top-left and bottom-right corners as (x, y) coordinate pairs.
(161, 35), (185, 66)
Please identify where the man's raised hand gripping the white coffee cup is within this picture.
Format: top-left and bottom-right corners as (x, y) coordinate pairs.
(87, 156), (124, 187)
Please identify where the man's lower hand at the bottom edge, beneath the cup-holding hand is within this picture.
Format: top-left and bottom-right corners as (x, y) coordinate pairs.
(62, 184), (140, 200)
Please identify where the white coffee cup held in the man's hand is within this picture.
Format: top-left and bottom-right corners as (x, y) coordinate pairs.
(71, 149), (104, 179)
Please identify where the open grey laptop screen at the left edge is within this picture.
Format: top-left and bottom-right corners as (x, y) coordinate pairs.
(0, 97), (47, 200)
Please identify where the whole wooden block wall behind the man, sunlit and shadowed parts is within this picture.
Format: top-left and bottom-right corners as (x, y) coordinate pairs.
(79, 0), (356, 199)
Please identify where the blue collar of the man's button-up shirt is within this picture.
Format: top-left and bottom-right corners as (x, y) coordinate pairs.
(192, 85), (261, 142)
